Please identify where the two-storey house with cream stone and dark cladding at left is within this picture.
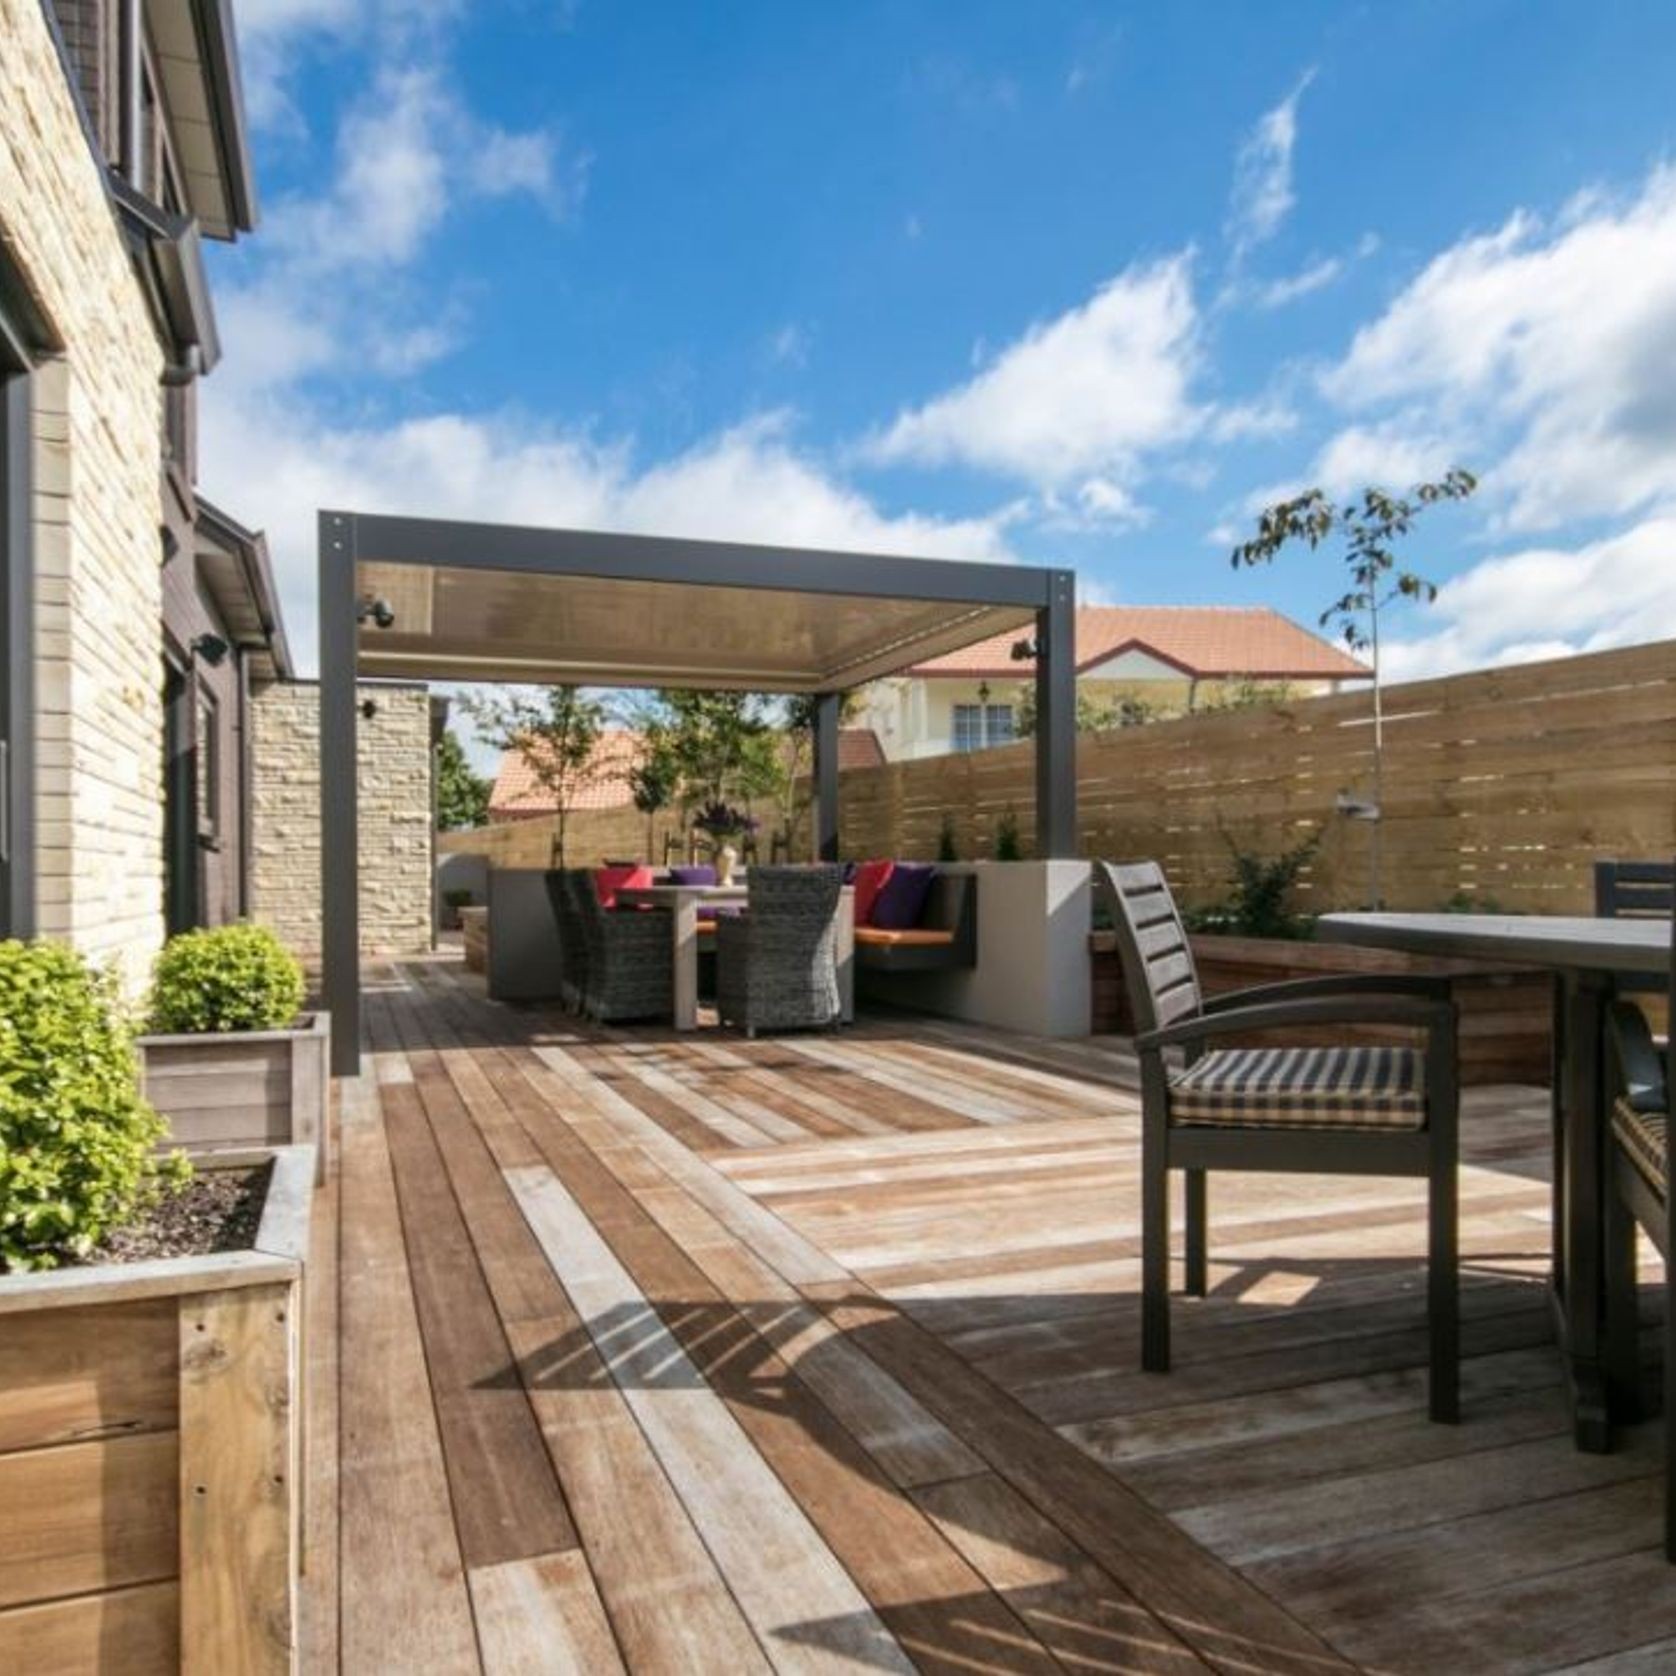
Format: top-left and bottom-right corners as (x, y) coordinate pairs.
(0, 0), (292, 982)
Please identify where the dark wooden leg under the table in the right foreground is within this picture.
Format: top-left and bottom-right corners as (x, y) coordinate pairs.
(1554, 972), (1611, 1453)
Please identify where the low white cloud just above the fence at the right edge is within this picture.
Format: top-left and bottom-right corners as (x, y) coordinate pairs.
(1383, 515), (1676, 680)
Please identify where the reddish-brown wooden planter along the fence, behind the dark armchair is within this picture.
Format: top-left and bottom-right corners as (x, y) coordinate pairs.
(1089, 932), (1554, 1086)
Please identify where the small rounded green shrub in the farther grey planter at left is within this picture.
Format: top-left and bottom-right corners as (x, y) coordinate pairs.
(151, 925), (303, 1036)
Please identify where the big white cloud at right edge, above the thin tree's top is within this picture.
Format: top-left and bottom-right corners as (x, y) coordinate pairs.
(1322, 166), (1676, 530)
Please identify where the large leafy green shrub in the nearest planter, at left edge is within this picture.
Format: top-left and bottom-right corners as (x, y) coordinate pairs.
(0, 942), (188, 1269)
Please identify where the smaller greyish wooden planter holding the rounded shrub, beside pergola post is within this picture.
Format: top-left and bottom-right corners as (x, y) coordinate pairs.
(139, 1012), (332, 1182)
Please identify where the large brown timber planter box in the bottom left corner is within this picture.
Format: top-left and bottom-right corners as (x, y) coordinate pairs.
(0, 1146), (315, 1676)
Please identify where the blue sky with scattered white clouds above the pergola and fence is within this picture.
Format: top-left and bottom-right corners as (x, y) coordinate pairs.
(203, 0), (1676, 675)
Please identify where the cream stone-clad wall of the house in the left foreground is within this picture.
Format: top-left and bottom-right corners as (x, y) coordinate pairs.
(0, 0), (163, 984)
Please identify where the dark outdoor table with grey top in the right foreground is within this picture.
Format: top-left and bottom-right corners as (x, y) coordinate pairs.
(1317, 913), (1671, 1453)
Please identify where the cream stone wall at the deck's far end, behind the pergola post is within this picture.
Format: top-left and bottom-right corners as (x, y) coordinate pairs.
(250, 680), (432, 964)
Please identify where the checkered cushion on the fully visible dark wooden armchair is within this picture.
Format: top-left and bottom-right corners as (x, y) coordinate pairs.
(1170, 1048), (1426, 1130)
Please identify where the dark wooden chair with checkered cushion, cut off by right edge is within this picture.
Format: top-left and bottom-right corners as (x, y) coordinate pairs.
(1606, 923), (1676, 1560)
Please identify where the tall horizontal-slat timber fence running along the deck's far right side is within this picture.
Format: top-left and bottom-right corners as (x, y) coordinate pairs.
(444, 640), (1676, 913)
